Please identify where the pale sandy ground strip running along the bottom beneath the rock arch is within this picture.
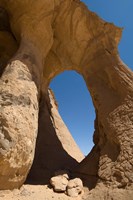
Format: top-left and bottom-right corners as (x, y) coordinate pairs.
(0, 185), (133, 200)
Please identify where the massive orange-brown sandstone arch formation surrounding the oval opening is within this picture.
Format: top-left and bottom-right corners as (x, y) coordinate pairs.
(0, 0), (133, 195)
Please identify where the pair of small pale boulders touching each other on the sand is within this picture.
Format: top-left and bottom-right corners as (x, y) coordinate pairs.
(50, 171), (83, 197)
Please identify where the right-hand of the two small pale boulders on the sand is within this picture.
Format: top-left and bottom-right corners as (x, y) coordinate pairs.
(67, 178), (83, 197)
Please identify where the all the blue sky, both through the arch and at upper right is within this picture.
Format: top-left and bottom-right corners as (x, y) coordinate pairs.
(50, 0), (133, 155)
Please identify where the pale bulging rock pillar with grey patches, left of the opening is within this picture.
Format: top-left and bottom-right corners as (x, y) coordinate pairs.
(0, 42), (40, 189)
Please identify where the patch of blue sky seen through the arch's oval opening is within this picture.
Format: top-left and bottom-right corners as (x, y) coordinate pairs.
(49, 70), (96, 156)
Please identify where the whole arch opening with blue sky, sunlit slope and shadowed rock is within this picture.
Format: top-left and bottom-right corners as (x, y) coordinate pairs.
(27, 70), (95, 184)
